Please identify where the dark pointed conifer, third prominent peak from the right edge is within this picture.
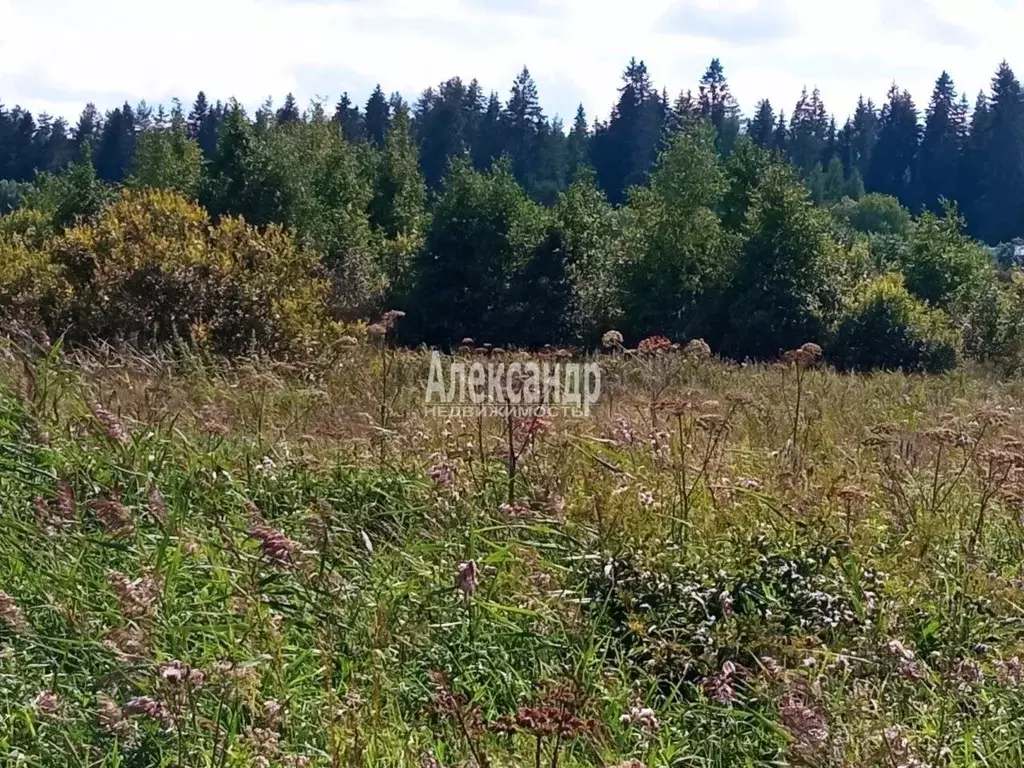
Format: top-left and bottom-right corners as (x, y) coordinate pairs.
(867, 84), (921, 209)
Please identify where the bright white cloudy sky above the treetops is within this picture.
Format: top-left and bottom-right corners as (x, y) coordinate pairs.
(0, 0), (1024, 128)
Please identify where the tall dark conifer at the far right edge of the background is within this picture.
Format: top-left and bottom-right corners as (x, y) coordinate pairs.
(980, 61), (1024, 245)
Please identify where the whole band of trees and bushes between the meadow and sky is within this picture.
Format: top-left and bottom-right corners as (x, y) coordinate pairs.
(0, 59), (1024, 372)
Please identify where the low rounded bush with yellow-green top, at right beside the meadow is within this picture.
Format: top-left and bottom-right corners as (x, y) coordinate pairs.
(827, 274), (959, 373)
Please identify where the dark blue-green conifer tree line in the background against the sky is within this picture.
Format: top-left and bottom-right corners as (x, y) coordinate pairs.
(6, 59), (1024, 245)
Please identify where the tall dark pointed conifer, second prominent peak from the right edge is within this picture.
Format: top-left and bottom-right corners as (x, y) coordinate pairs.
(918, 72), (967, 213)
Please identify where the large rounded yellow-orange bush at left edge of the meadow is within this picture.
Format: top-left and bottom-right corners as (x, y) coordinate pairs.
(41, 190), (333, 356)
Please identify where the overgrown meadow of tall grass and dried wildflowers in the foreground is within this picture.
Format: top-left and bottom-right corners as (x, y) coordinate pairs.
(0, 338), (1024, 768)
